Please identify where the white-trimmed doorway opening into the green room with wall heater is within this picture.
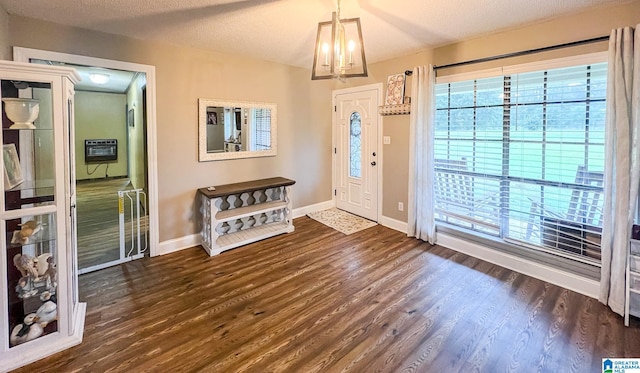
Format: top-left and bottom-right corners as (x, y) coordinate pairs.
(14, 48), (157, 274)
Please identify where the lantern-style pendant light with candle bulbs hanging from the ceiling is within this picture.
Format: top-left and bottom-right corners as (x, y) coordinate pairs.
(311, 0), (367, 80)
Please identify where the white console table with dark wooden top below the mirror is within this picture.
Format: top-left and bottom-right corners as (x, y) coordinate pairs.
(198, 177), (295, 256)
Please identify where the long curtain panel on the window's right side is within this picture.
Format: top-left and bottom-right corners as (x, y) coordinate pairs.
(600, 25), (640, 315)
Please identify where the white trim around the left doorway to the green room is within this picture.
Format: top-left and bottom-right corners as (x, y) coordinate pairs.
(13, 47), (161, 256)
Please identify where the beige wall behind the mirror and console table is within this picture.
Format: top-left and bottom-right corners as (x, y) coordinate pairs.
(10, 16), (331, 241)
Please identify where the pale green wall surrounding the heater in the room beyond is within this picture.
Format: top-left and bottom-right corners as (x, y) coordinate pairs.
(75, 92), (127, 180)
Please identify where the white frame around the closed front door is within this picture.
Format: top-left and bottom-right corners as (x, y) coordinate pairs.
(331, 83), (384, 222)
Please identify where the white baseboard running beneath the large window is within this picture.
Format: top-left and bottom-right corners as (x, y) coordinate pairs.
(436, 233), (600, 299)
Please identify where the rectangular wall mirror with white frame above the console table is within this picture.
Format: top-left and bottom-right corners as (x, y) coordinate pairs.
(198, 98), (277, 162)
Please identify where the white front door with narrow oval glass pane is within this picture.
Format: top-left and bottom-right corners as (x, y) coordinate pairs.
(335, 88), (380, 221)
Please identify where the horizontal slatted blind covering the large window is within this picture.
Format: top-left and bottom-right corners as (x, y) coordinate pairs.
(434, 63), (607, 261)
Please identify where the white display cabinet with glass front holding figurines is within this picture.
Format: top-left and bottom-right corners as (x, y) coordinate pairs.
(0, 61), (86, 371)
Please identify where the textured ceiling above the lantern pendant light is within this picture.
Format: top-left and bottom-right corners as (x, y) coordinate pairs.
(0, 0), (629, 68)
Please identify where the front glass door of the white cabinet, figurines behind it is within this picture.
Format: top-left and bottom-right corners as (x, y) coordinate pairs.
(0, 80), (59, 348)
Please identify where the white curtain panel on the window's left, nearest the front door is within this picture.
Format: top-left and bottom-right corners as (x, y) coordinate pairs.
(407, 65), (436, 244)
